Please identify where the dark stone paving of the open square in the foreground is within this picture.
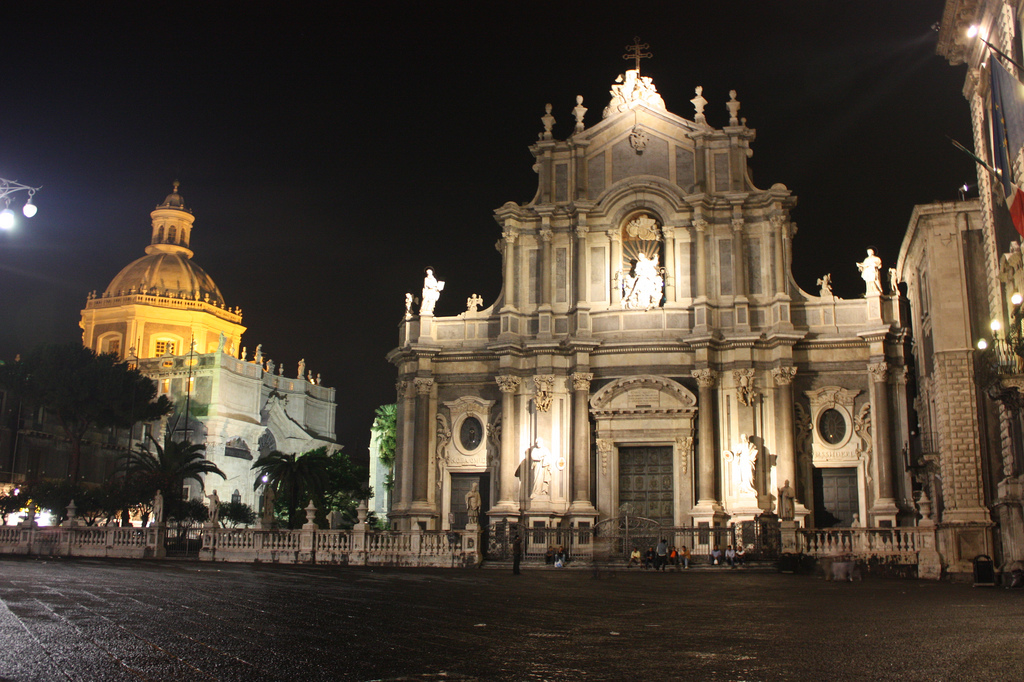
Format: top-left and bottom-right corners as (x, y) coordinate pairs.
(0, 559), (1024, 682)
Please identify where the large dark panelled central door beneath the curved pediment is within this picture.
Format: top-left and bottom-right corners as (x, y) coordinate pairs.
(618, 445), (674, 527)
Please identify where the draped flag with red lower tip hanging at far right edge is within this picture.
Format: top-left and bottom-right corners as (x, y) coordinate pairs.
(989, 59), (1024, 237)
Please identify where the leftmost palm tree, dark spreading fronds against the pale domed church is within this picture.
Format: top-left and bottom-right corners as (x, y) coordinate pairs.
(122, 431), (226, 512)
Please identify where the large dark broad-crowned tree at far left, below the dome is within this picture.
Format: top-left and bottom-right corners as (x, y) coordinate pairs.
(0, 343), (172, 483)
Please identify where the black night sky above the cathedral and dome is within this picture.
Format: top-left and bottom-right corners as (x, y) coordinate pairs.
(0, 0), (975, 457)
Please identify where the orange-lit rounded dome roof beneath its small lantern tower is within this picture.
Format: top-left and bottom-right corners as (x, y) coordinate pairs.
(105, 252), (224, 305)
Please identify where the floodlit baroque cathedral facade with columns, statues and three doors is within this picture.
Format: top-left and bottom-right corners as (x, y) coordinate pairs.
(388, 69), (918, 528)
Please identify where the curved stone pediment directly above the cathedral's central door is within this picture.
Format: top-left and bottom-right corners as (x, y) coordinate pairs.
(590, 375), (697, 418)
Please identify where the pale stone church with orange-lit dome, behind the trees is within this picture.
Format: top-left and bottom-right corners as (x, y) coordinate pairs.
(80, 183), (336, 506)
